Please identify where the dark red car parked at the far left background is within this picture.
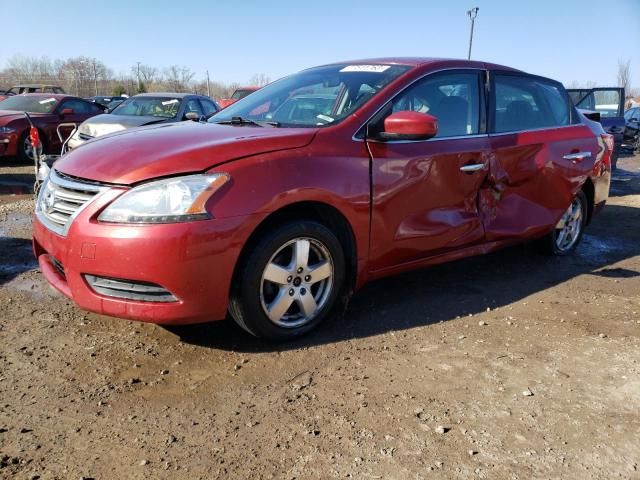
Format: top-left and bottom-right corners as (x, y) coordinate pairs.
(0, 93), (104, 161)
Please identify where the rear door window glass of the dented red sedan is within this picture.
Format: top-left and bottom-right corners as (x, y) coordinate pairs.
(493, 75), (571, 133)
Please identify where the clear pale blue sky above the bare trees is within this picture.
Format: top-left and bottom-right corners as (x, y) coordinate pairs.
(0, 0), (640, 87)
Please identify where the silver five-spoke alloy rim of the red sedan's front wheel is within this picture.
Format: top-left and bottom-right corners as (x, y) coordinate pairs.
(260, 237), (334, 328)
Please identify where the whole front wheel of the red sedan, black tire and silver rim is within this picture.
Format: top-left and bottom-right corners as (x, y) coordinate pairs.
(229, 220), (345, 340)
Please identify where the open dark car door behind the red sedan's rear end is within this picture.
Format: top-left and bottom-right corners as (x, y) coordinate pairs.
(567, 87), (625, 170)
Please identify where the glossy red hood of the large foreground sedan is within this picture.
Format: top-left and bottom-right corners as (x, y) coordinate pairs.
(55, 122), (317, 185)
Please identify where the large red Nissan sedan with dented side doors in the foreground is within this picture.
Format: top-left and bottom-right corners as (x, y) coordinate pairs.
(33, 58), (612, 338)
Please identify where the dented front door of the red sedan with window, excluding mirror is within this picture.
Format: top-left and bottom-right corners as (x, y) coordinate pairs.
(367, 70), (490, 271)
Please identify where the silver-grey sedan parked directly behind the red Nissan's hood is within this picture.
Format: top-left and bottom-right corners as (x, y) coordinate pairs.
(69, 93), (220, 149)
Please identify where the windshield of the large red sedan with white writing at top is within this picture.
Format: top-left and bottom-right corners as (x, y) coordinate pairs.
(209, 64), (411, 127)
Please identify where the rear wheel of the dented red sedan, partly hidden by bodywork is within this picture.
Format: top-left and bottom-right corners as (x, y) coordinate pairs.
(540, 190), (588, 256)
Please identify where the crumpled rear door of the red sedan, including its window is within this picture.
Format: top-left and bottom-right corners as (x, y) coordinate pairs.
(481, 71), (598, 241)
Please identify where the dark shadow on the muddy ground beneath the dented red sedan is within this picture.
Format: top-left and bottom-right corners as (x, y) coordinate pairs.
(170, 199), (640, 352)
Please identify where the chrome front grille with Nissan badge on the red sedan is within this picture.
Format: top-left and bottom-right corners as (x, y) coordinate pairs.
(36, 170), (107, 235)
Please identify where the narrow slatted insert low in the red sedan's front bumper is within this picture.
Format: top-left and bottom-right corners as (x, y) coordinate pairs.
(84, 274), (178, 302)
